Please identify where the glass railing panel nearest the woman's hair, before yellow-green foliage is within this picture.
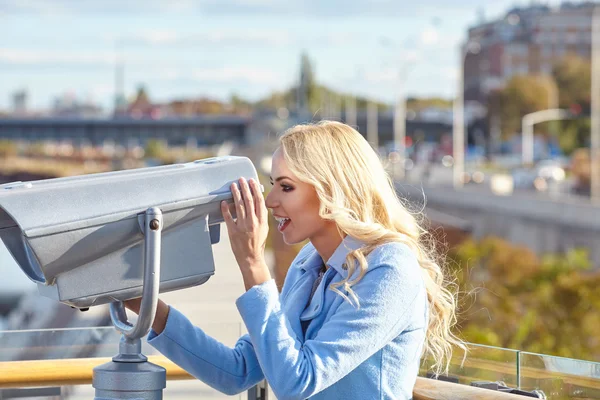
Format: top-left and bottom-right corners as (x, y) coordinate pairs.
(419, 344), (518, 387)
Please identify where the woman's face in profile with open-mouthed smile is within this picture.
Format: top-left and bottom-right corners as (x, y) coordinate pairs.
(265, 148), (337, 244)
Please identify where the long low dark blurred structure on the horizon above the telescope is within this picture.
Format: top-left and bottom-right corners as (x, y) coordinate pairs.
(0, 116), (250, 146)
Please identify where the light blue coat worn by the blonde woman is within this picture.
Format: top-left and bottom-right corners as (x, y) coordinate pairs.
(148, 237), (428, 400)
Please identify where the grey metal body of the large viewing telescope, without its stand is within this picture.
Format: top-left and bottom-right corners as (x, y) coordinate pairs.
(0, 156), (258, 308)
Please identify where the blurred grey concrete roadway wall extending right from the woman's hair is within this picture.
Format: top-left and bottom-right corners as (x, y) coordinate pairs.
(396, 183), (600, 265)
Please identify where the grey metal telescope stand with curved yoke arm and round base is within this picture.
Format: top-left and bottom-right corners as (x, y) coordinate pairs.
(92, 208), (167, 400)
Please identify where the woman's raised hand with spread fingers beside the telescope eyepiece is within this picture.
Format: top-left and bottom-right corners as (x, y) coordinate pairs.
(221, 178), (271, 290)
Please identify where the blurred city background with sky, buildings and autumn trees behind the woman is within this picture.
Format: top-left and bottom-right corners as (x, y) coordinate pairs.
(0, 0), (600, 398)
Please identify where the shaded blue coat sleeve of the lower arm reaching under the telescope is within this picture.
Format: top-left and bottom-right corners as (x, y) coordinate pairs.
(148, 307), (264, 395)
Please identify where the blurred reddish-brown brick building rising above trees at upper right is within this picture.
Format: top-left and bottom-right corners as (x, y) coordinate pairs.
(463, 2), (595, 103)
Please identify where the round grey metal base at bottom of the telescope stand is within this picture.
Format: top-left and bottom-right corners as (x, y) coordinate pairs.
(92, 361), (167, 400)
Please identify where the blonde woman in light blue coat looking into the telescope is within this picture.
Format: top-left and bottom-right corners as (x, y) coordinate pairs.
(128, 121), (461, 399)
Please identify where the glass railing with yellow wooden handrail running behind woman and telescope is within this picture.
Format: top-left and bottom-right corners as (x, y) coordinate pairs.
(0, 324), (600, 400)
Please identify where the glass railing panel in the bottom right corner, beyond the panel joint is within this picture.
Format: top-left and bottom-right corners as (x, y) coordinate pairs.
(519, 352), (600, 400)
